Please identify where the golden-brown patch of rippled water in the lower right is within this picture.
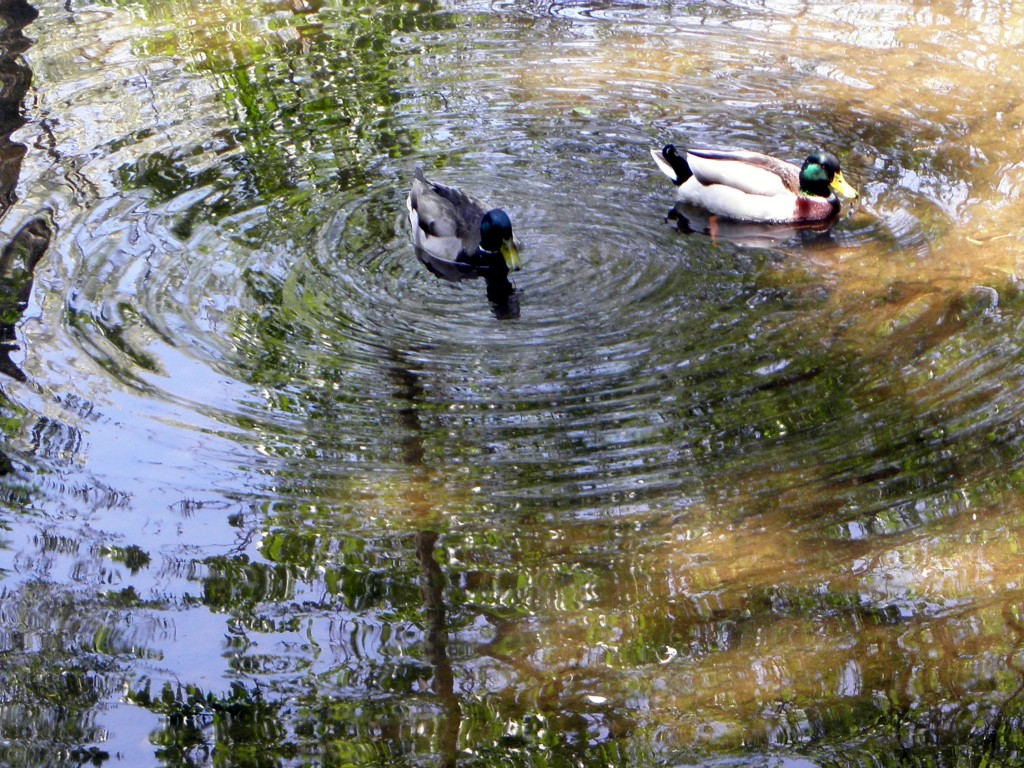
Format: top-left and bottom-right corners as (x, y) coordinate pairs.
(501, 489), (1024, 746)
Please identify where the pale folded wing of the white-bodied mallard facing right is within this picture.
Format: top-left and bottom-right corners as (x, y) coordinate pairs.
(686, 150), (800, 196)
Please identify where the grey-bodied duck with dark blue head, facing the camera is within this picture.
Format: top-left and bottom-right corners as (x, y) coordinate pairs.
(407, 168), (522, 271)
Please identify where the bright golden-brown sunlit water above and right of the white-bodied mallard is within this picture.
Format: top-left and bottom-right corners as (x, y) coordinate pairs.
(503, 2), (1024, 327)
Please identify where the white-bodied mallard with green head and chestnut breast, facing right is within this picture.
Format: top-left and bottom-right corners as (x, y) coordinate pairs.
(650, 144), (858, 224)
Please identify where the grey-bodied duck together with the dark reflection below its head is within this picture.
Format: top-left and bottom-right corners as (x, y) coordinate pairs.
(407, 168), (522, 319)
